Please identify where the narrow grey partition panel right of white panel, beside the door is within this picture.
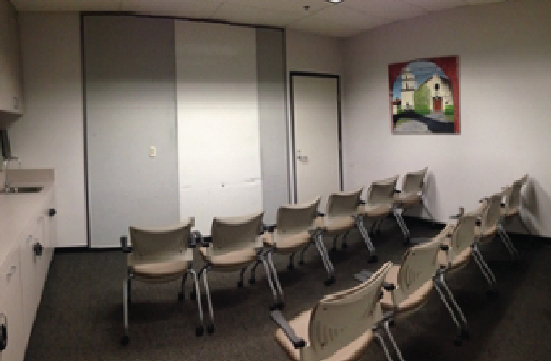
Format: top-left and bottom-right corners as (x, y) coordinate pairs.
(256, 28), (290, 224)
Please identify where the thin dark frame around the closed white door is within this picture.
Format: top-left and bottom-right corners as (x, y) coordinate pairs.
(289, 71), (344, 204)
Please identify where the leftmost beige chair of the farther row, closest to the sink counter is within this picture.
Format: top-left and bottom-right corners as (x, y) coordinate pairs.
(121, 218), (203, 345)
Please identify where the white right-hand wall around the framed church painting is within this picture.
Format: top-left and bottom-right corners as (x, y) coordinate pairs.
(343, 1), (551, 236)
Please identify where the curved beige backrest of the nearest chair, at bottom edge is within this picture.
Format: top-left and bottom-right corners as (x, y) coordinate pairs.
(301, 262), (392, 361)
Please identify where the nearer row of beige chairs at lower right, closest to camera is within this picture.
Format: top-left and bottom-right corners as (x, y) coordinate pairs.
(271, 176), (530, 361)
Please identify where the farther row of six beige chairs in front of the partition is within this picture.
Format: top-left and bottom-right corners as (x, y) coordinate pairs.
(121, 168), (430, 344)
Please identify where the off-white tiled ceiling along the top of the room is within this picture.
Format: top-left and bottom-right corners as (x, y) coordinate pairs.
(11, 0), (508, 37)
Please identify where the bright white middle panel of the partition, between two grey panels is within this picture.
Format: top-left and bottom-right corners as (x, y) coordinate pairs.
(174, 21), (262, 234)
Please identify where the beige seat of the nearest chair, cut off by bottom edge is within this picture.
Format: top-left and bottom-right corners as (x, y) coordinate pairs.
(275, 310), (374, 361)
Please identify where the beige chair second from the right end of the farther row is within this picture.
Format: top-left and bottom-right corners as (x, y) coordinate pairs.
(360, 175), (410, 244)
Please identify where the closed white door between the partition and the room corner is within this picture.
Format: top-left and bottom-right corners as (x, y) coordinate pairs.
(291, 74), (341, 212)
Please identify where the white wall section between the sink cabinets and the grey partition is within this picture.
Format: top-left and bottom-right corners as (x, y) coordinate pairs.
(9, 13), (86, 247)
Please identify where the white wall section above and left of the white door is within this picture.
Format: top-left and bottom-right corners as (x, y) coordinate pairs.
(285, 29), (345, 198)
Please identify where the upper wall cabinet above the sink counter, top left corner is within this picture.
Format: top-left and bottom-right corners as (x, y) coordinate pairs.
(0, 0), (23, 114)
